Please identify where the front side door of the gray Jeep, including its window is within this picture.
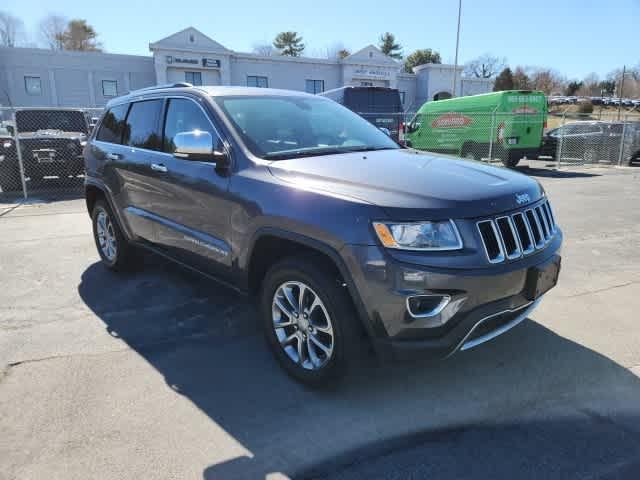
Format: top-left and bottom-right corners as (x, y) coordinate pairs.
(150, 98), (231, 276)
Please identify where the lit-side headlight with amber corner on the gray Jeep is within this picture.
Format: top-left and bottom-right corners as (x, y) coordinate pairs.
(373, 220), (462, 250)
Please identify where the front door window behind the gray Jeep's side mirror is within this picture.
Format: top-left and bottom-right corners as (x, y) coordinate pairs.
(163, 98), (223, 153)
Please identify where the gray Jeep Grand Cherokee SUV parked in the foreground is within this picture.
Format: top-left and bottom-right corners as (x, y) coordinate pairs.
(84, 84), (562, 385)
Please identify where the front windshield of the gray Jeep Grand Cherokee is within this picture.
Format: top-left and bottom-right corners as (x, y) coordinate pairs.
(216, 96), (400, 160)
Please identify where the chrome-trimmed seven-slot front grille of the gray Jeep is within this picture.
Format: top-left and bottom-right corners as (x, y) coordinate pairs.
(476, 200), (558, 263)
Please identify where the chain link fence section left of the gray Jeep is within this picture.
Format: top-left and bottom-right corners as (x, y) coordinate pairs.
(0, 108), (102, 200)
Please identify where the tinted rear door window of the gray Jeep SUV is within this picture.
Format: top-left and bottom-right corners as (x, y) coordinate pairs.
(122, 100), (162, 150)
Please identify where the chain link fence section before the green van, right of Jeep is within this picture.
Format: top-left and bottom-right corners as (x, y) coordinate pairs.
(360, 107), (640, 168)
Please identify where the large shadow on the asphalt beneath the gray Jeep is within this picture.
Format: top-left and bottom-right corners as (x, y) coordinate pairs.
(78, 255), (640, 480)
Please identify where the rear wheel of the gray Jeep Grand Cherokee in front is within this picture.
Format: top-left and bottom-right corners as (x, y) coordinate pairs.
(91, 199), (134, 271)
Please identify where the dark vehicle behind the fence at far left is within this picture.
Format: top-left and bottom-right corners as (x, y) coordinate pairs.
(15, 108), (89, 184)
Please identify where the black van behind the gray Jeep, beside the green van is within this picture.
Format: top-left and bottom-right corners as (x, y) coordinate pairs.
(318, 86), (404, 142)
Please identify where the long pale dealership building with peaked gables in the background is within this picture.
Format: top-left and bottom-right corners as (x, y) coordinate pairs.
(0, 27), (493, 110)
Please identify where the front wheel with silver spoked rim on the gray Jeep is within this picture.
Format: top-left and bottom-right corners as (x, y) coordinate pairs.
(260, 255), (361, 388)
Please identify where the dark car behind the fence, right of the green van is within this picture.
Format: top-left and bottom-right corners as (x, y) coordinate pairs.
(540, 121), (640, 165)
